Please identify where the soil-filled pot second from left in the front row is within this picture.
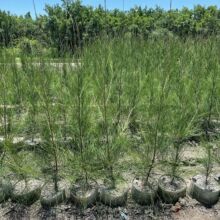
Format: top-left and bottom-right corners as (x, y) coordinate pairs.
(11, 180), (43, 206)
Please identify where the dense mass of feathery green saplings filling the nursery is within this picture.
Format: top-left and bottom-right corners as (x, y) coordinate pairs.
(0, 38), (220, 210)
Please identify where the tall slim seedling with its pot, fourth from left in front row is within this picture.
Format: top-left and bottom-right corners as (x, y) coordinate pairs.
(69, 56), (98, 208)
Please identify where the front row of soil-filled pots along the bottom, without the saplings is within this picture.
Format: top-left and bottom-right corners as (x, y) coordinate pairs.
(0, 166), (220, 208)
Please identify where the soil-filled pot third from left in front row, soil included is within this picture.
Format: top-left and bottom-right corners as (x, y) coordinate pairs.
(40, 184), (66, 209)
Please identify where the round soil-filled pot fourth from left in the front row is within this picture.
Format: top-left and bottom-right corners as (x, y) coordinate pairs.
(70, 181), (98, 208)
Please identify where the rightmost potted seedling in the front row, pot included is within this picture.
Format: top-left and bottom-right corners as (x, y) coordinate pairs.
(190, 61), (220, 207)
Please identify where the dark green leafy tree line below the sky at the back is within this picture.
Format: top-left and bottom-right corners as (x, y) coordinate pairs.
(0, 0), (220, 53)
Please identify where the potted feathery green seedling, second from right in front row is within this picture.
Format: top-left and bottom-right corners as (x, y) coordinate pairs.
(158, 68), (197, 203)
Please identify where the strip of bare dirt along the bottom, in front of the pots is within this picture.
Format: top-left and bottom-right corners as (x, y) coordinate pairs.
(0, 193), (220, 220)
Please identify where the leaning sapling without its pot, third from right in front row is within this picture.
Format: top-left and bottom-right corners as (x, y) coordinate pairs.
(145, 69), (170, 184)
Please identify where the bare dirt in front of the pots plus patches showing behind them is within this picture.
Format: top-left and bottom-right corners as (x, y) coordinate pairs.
(0, 144), (220, 220)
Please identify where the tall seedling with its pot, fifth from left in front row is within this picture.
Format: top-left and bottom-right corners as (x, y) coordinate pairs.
(90, 41), (128, 206)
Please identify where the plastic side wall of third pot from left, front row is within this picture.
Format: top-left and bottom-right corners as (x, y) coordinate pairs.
(40, 189), (66, 209)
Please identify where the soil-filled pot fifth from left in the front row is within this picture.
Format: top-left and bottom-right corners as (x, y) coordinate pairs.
(99, 181), (129, 207)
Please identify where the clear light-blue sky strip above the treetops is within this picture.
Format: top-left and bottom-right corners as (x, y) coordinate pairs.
(0, 0), (220, 17)
